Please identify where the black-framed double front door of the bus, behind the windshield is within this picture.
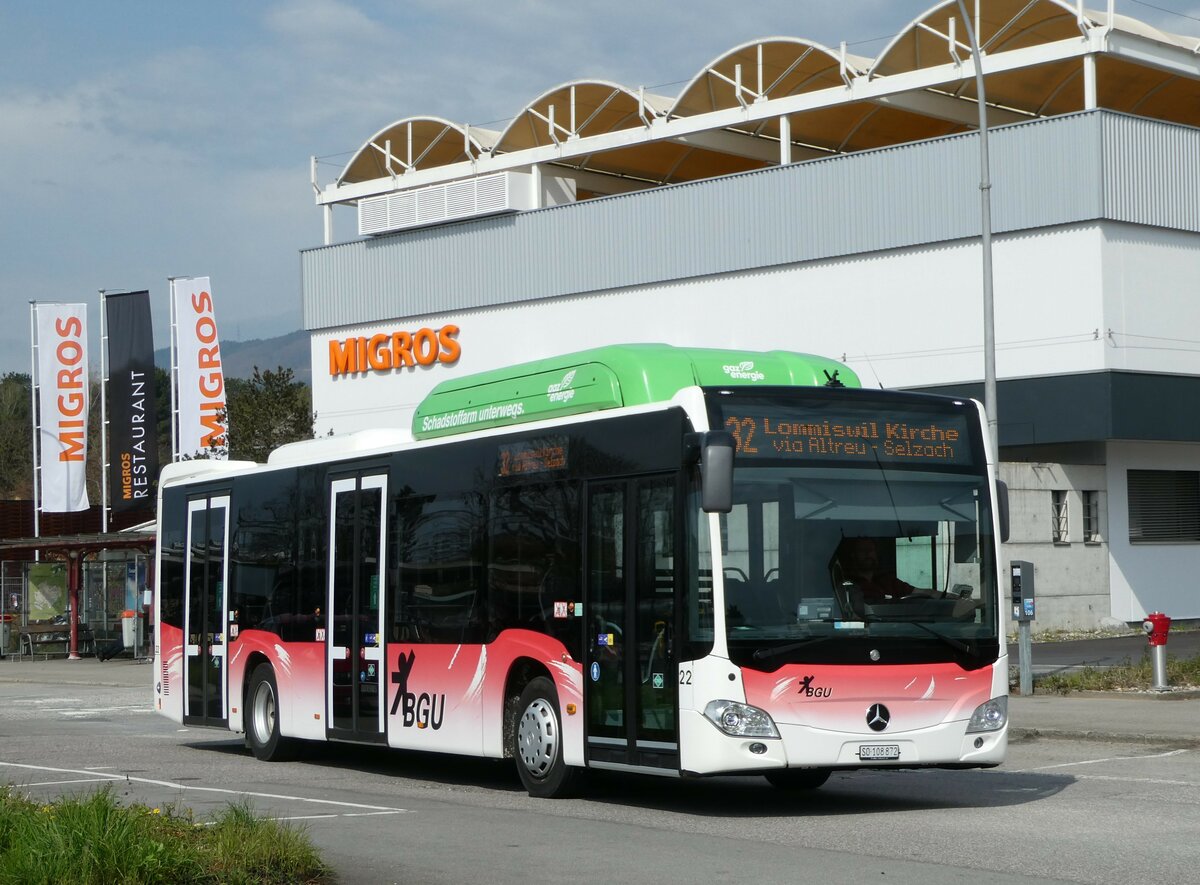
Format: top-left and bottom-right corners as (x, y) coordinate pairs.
(583, 476), (679, 770)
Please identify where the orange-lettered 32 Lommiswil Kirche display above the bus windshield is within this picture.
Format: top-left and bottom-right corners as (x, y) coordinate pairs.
(725, 405), (972, 464)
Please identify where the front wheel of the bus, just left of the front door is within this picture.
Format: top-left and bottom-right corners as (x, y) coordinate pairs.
(512, 676), (580, 799)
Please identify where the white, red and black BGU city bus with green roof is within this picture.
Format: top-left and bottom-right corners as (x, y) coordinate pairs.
(154, 344), (1008, 797)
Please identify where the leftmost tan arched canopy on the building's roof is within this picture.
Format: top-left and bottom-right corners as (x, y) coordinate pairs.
(337, 116), (496, 185)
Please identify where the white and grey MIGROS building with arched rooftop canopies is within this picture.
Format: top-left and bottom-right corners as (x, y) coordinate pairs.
(295, 0), (1200, 628)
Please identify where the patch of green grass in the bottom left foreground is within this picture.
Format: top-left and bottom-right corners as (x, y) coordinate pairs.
(0, 787), (332, 885)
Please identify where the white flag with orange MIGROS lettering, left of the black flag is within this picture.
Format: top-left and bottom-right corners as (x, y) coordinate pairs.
(34, 305), (89, 513)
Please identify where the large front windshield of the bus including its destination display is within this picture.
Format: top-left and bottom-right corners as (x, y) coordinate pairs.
(697, 390), (1000, 670)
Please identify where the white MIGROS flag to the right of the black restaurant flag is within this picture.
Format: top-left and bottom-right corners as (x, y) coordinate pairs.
(170, 277), (229, 458)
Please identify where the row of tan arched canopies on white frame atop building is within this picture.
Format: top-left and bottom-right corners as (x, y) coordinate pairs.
(313, 0), (1200, 227)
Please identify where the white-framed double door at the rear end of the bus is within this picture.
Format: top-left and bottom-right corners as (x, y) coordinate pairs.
(184, 495), (229, 726)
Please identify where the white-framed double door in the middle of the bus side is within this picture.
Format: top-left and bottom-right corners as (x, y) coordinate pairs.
(325, 474), (388, 741)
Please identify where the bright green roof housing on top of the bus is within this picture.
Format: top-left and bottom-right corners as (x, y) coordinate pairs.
(413, 344), (860, 439)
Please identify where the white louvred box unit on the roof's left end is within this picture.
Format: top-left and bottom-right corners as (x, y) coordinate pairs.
(359, 171), (534, 236)
